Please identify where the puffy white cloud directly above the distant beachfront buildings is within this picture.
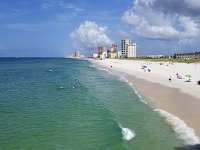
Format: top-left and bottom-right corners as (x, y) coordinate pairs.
(70, 21), (112, 49)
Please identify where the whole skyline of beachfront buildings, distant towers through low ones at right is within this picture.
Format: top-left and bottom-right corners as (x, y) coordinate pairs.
(70, 38), (200, 59)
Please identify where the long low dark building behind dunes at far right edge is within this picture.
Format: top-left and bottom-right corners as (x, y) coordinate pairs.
(174, 52), (200, 59)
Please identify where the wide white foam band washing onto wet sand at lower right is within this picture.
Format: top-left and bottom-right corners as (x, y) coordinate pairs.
(154, 109), (200, 145)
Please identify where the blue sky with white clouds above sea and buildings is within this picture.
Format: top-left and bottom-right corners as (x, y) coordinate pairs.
(0, 0), (200, 57)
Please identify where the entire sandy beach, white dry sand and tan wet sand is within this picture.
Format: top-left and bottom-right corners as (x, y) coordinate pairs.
(93, 59), (200, 141)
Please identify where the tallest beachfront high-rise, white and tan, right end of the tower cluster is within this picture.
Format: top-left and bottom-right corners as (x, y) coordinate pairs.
(121, 38), (136, 58)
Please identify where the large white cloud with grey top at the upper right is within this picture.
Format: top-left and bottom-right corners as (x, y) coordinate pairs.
(122, 0), (200, 40)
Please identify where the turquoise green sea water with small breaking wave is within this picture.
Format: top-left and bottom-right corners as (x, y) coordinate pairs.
(0, 58), (184, 150)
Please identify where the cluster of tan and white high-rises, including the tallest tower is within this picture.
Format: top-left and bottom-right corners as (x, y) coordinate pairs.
(92, 38), (136, 59)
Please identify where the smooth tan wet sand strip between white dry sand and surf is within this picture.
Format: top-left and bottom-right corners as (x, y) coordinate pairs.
(126, 75), (200, 137)
